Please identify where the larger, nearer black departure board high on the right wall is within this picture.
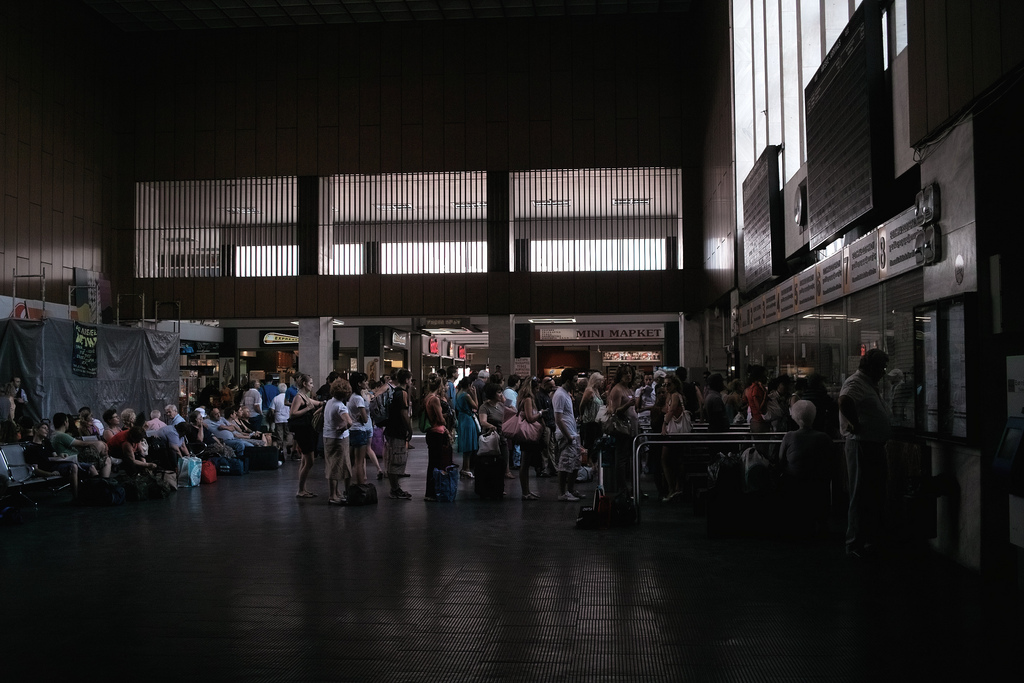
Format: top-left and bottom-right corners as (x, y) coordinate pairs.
(804, 0), (892, 249)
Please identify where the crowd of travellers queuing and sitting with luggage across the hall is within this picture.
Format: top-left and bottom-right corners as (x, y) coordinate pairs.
(0, 352), (888, 553)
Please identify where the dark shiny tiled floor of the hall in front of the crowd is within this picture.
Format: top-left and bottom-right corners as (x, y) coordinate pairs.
(0, 440), (1024, 681)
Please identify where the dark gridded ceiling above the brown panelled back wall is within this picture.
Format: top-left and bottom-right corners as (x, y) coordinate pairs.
(83, 0), (692, 33)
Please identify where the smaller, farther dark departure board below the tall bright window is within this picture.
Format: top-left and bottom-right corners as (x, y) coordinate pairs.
(743, 144), (785, 292)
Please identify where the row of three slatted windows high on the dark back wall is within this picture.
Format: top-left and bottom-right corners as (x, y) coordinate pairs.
(135, 168), (682, 278)
